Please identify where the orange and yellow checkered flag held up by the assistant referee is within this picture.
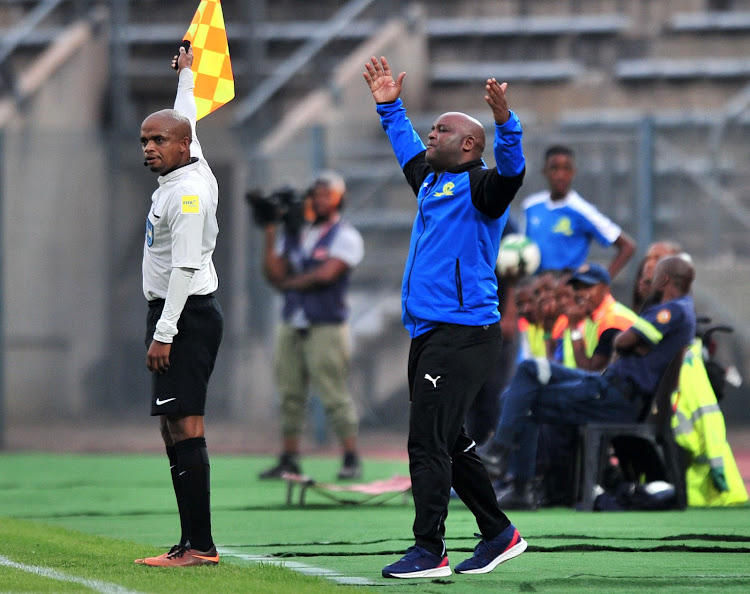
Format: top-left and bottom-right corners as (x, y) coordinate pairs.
(185, 0), (234, 119)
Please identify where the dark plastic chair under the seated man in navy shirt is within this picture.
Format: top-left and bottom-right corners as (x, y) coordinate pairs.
(575, 349), (687, 511)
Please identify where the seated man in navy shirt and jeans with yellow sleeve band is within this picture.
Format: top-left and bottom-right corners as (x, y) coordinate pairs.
(485, 256), (695, 509)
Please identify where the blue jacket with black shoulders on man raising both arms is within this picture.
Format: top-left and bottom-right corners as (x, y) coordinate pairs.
(377, 99), (526, 338)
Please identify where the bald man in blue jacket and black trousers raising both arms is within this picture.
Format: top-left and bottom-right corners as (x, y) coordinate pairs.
(364, 57), (526, 578)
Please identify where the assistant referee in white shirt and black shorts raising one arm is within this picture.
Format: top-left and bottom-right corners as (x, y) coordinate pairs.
(135, 47), (224, 567)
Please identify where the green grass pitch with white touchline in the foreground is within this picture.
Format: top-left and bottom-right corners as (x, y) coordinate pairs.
(0, 453), (750, 593)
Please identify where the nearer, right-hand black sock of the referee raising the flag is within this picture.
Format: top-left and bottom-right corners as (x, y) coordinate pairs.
(174, 437), (214, 551)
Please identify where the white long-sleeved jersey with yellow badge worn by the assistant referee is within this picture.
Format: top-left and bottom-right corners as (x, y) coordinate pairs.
(143, 69), (219, 301)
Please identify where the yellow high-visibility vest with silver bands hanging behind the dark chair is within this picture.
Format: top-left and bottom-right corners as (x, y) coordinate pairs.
(672, 338), (748, 507)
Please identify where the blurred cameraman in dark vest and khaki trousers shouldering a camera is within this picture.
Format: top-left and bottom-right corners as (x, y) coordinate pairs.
(249, 172), (364, 479)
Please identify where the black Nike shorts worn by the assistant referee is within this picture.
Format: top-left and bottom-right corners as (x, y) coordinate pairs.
(145, 295), (224, 416)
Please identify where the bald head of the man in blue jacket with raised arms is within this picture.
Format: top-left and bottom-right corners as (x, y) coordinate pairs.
(425, 111), (485, 173)
